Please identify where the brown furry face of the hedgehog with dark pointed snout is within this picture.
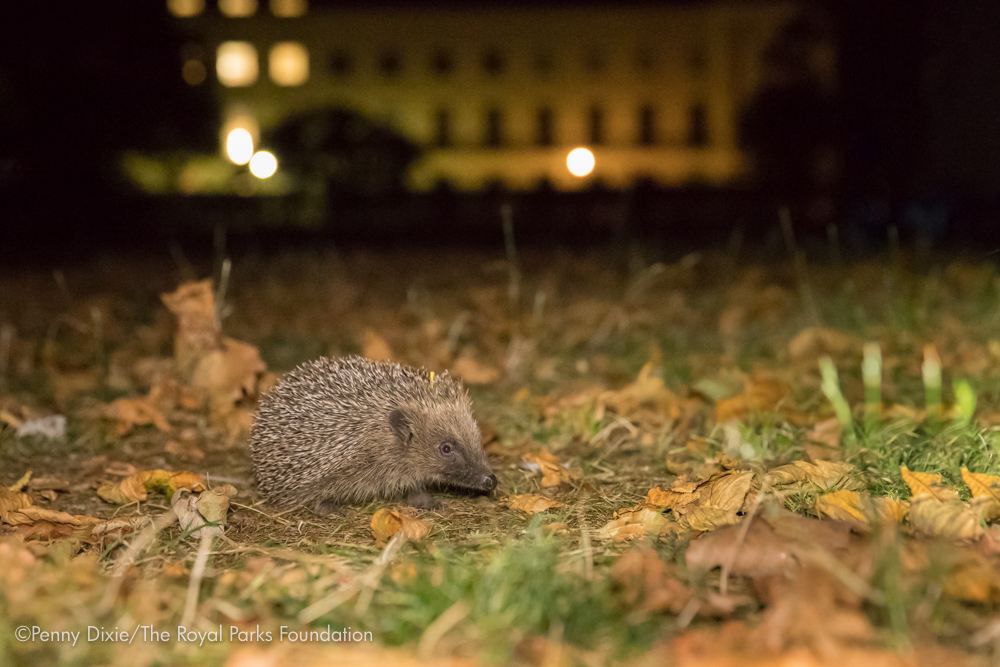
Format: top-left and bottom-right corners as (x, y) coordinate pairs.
(389, 405), (497, 492)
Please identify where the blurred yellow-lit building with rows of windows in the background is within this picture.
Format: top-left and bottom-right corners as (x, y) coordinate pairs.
(166, 0), (812, 190)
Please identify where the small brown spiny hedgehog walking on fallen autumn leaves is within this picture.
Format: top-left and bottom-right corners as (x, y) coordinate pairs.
(250, 356), (497, 515)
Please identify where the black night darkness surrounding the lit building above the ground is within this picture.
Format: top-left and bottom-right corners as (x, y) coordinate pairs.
(0, 0), (1000, 261)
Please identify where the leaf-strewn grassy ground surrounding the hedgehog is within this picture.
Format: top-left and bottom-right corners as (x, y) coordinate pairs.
(0, 248), (1000, 667)
